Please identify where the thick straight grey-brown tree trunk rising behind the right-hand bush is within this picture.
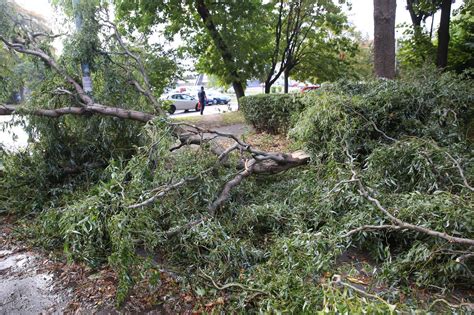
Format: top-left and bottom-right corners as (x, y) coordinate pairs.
(374, 0), (397, 79)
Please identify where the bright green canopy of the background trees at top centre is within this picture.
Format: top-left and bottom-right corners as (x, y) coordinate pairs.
(117, 0), (356, 97)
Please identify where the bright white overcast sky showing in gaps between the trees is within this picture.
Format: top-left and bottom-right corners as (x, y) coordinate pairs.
(15, 0), (461, 38)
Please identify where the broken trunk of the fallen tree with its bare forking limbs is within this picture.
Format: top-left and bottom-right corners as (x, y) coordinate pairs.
(0, 20), (309, 213)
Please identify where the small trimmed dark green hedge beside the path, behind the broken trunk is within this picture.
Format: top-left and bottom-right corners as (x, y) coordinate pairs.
(240, 94), (304, 134)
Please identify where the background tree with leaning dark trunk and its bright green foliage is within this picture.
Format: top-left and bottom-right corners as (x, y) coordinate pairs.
(116, 0), (269, 98)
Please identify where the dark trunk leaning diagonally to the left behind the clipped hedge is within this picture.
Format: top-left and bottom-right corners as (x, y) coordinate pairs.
(195, 0), (245, 99)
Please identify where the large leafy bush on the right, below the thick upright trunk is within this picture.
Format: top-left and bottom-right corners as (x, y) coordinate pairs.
(291, 69), (474, 161)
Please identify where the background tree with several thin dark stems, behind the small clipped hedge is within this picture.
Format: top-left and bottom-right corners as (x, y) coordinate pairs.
(265, 0), (347, 93)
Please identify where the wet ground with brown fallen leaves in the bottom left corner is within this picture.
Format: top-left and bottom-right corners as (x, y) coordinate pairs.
(0, 216), (195, 315)
